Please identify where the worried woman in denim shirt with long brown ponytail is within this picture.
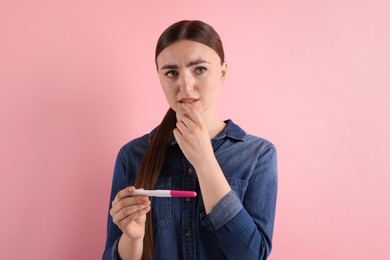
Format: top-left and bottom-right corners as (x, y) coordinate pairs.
(103, 21), (277, 259)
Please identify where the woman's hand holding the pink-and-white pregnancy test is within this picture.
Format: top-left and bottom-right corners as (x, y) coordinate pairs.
(110, 186), (150, 240)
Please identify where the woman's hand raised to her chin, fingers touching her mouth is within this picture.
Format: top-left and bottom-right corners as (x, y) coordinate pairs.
(173, 104), (214, 167)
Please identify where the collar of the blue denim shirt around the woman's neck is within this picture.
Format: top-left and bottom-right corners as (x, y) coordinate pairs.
(148, 119), (247, 145)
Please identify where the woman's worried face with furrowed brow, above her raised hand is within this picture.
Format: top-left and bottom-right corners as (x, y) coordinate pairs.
(157, 40), (226, 115)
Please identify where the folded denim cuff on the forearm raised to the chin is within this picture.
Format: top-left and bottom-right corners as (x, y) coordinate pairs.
(200, 190), (243, 230)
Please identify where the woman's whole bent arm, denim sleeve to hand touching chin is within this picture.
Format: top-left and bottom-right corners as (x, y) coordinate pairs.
(174, 107), (277, 259)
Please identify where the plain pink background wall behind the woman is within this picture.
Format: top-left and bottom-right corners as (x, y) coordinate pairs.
(0, 0), (390, 260)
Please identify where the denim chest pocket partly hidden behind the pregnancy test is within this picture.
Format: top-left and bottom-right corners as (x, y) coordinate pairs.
(152, 177), (172, 230)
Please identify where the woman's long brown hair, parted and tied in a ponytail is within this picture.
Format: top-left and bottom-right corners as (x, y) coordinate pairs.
(134, 20), (225, 260)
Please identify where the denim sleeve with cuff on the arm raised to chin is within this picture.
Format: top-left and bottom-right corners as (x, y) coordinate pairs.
(201, 145), (277, 259)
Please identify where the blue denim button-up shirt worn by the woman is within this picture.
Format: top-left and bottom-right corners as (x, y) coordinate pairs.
(103, 120), (277, 260)
